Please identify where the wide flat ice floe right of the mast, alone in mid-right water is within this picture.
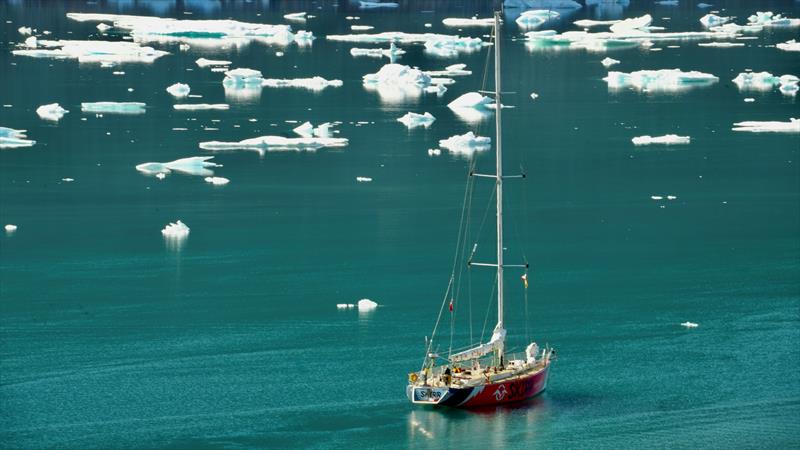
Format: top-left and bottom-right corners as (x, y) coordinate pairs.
(603, 69), (719, 92)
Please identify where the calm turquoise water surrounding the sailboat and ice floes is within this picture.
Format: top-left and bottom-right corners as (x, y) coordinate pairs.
(0, 1), (800, 448)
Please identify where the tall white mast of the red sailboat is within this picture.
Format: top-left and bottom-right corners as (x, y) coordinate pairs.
(494, 11), (504, 342)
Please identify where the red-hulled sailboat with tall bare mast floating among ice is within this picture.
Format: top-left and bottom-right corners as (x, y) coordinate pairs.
(406, 12), (555, 408)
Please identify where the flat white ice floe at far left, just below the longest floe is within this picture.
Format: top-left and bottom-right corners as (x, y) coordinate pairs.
(11, 40), (169, 64)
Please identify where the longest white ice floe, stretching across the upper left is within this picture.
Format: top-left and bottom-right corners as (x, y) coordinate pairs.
(67, 13), (314, 47)
